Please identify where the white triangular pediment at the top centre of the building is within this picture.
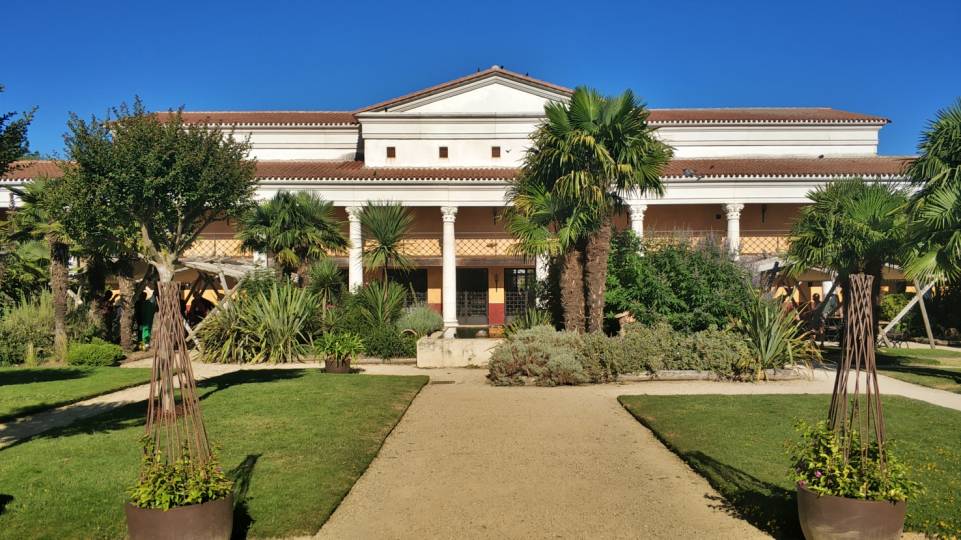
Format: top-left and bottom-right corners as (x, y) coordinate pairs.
(361, 67), (571, 115)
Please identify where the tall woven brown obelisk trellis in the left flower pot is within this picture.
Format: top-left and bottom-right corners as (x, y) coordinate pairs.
(147, 282), (210, 465)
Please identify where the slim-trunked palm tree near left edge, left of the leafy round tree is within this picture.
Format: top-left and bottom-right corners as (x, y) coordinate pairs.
(9, 178), (70, 361)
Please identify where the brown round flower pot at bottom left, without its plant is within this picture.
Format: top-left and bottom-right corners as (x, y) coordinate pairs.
(125, 495), (234, 540)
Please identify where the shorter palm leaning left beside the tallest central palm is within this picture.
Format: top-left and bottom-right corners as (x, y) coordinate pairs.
(503, 175), (589, 332)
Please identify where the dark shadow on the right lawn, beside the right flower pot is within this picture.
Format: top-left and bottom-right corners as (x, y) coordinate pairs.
(680, 452), (803, 538)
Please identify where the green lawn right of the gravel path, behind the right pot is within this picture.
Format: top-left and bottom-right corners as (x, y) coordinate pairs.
(620, 394), (961, 538)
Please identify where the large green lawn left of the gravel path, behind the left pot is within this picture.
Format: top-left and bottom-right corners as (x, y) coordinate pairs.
(0, 369), (427, 539)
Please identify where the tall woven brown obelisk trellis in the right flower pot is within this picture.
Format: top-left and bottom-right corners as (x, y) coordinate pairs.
(828, 274), (884, 466)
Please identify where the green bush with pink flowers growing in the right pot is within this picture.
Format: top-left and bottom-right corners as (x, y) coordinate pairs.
(791, 420), (920, 501)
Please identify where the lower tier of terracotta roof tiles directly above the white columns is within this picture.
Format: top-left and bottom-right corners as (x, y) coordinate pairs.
(2, 156), (911, 181)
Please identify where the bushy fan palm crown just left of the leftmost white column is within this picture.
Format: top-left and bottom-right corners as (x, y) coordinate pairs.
(237, 191), (347, 283)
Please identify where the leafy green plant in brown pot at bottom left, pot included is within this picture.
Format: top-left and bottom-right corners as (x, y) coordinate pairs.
(125, 436), (234, 540)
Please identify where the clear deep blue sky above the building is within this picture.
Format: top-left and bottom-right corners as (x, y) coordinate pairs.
(0, 0), (961, 154)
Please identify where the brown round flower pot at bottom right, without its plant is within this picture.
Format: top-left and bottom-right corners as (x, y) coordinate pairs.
(797, 484), (907, 540)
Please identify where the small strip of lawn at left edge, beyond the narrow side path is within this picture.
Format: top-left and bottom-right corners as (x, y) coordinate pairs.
(0, 367), (150, 421)
